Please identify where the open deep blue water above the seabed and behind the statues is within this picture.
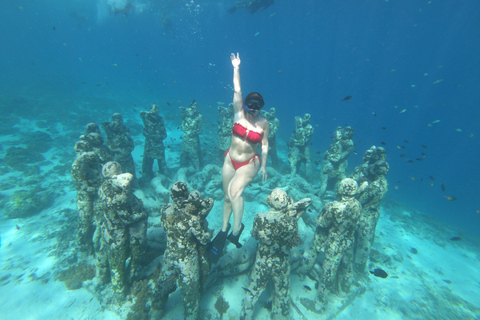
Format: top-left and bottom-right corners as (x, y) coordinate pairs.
(0, 0), (480, 232)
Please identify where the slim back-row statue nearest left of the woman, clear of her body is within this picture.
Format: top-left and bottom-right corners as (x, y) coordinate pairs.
(180, 100), (203, 172)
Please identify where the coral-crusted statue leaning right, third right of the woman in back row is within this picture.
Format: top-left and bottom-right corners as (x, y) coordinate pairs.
(318, 127), (354, 197)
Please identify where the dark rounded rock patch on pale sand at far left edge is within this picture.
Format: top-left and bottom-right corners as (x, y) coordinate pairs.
(5, 187), (53, 219)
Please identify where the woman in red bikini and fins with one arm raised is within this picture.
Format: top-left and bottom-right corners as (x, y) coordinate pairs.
(206, 53), (269, 263)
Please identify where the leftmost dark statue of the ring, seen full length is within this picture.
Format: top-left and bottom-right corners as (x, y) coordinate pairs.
(72, 140), (103, 253)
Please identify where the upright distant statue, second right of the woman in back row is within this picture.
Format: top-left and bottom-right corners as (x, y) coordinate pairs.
(287, 113), (314, 178)
